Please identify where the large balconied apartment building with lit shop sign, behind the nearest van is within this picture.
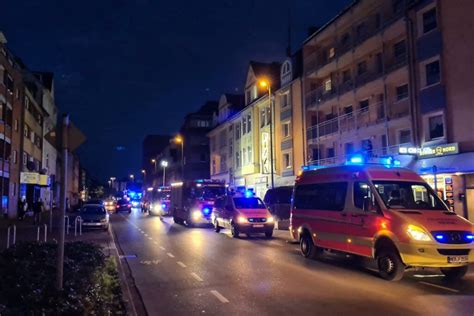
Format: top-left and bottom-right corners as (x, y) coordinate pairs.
(303, 0), (474, 219)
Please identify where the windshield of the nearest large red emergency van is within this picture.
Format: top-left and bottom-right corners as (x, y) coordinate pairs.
(374, 181), (447, 211)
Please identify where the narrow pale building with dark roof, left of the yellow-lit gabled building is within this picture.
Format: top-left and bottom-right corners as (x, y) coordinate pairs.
(208, 93), (244, 183)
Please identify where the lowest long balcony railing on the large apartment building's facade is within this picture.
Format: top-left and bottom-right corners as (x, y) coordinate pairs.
(307, 100), (410, 141)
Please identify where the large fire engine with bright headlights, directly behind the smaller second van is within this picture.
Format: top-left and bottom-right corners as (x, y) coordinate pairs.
(170, 180), (226, 227)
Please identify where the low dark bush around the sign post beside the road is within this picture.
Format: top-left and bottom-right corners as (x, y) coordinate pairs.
(0, 242), (125, 315)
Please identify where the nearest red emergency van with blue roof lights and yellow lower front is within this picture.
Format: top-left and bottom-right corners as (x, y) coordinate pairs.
(290, 157), (474, 281)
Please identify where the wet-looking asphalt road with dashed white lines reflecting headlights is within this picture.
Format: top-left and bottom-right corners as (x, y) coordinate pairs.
(111, 210), (474, 316)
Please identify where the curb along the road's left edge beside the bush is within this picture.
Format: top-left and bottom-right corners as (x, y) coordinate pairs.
(109, 224), (148, 316)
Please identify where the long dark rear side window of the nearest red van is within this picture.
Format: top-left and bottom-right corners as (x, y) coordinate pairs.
(293, 182), (347, 212)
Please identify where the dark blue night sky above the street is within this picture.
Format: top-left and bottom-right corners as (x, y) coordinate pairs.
(0, 0), (351, 179)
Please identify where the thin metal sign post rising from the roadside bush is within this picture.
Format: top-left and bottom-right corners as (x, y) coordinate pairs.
(56, 114), (69, 290)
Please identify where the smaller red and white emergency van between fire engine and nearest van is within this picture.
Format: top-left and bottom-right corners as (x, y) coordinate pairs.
(211, 192), (275, 238)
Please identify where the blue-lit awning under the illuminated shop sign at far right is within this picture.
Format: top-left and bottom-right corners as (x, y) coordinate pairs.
(413, 152), (474, 174)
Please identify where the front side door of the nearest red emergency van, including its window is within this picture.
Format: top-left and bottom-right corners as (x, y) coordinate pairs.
(348, 181), (383, 257)
